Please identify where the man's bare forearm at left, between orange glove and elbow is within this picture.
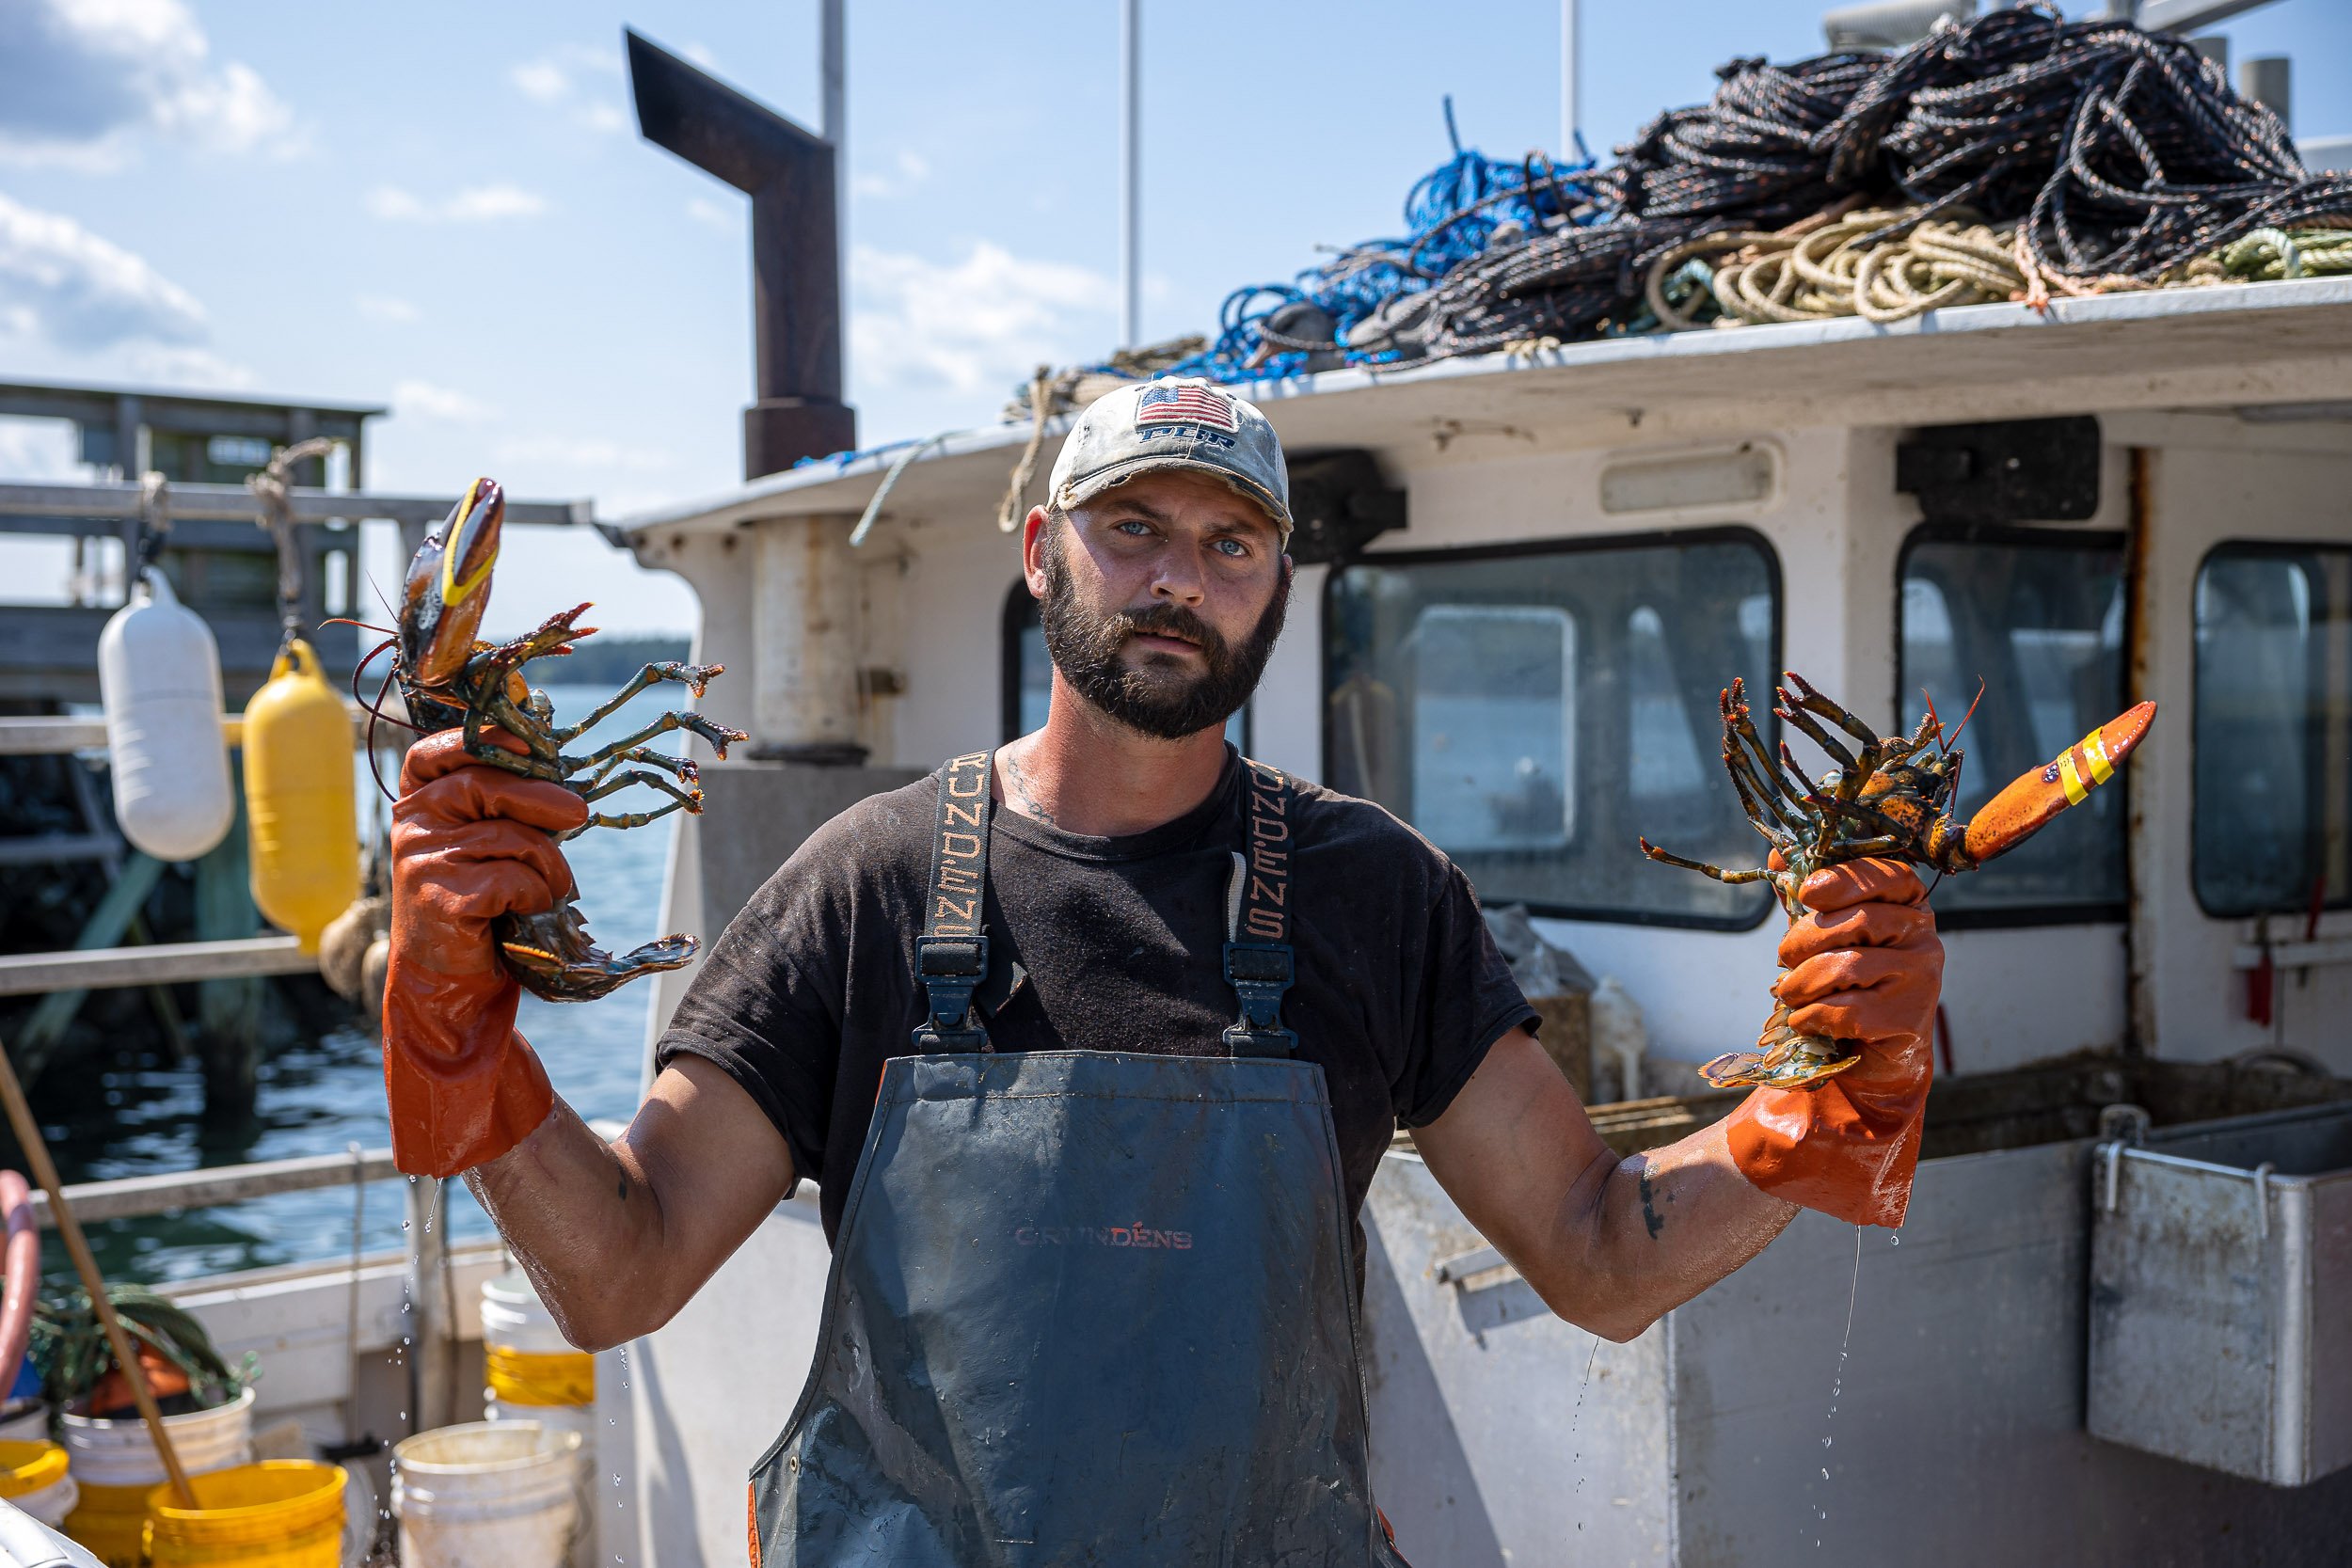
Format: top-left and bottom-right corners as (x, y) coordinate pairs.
(466, 1098), (675, 1350)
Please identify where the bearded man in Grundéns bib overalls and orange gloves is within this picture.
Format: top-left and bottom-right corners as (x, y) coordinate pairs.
(386, 383), (1943, 1563)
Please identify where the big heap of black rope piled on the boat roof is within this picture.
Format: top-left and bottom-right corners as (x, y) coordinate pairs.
(1400, 9), (2352, 357)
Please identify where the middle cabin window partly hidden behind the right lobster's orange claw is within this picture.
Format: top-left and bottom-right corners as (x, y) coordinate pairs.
(1896, 527), (2131, 927)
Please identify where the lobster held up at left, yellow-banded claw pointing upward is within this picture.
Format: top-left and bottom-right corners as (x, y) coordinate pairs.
(353, 480), (748, 1002)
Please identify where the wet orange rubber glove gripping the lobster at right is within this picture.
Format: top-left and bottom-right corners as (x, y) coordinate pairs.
(1724, 861), (1943, 1227)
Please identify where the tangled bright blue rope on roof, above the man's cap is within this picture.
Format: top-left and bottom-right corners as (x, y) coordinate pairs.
(1165, 94), (1604, 383)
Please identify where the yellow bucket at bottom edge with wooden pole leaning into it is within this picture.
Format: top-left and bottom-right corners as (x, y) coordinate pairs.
(146, 1460), (346, 1568)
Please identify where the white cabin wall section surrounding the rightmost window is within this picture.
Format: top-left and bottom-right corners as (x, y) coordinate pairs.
(2131, 441), (2352, 1074)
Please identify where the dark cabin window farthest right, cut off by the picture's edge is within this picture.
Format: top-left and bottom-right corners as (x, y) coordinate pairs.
(2190, 546), (2352, 914)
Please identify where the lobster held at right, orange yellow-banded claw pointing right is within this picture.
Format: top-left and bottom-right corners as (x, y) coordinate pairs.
(1642, 670), (2157, 1088)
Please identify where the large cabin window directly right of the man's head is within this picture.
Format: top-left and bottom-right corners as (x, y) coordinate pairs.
(1325, 529), (1781, 928)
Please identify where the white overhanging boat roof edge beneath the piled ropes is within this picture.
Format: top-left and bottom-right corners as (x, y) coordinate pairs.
(619, 277), (2352, 536)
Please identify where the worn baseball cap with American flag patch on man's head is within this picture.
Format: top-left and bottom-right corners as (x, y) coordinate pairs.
(1049, 376), (1292, 547)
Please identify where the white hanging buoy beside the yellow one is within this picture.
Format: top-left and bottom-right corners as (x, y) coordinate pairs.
(99, 571), (238, 861)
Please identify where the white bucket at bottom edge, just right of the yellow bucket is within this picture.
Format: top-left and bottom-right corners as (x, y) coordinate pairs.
(393, 1420), (581, 1568)
